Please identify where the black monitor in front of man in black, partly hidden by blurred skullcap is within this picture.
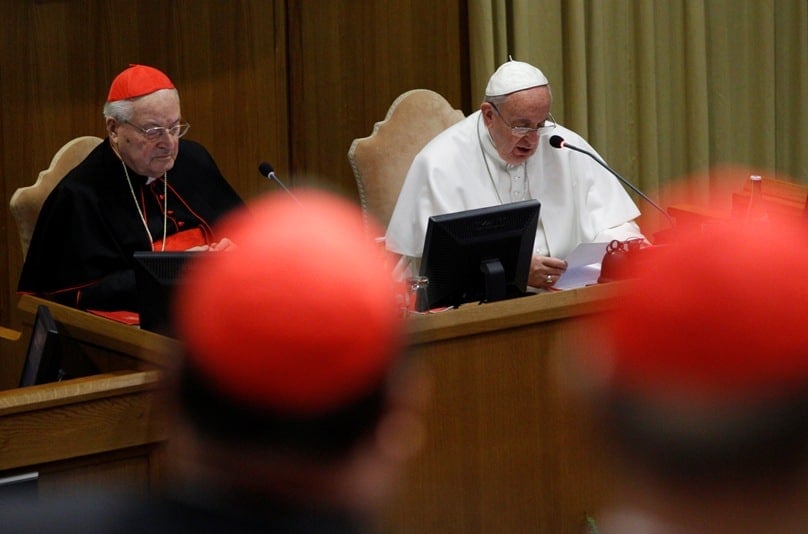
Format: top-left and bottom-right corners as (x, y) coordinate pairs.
(134, 251), (199, 335)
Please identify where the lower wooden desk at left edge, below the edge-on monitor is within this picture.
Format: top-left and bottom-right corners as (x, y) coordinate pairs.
(0, 371), (165, 497)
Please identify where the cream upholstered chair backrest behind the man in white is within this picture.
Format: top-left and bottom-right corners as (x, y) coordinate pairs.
(348, 89), (464, 228)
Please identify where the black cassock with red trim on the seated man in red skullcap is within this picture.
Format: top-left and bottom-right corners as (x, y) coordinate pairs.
(17, 139), (244, 310)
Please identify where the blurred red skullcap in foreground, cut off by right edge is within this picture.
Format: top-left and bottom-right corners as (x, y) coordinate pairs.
(590, 221), (808, 403)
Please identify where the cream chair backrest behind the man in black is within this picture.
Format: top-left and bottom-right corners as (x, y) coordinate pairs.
(9, 135), (102, 258)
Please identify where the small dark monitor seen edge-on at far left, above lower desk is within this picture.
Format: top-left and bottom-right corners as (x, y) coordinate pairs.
(20, 304), (65, 387)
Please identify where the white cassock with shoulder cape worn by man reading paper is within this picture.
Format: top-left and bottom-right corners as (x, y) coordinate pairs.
(386, 111), (643, 266)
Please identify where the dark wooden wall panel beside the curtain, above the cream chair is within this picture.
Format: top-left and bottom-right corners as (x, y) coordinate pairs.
(289, 0), (469, 195)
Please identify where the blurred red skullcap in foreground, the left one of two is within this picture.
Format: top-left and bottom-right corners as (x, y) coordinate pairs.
(176, 191), (403, 415)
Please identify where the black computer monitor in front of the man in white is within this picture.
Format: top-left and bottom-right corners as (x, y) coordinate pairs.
(416, 200), (541, 311)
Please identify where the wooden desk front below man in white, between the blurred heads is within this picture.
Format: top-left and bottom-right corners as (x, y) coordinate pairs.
(388, 284), (622, 533)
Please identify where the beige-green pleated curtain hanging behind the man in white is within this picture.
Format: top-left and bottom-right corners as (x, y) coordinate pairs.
(468, 0), (808, 234)
